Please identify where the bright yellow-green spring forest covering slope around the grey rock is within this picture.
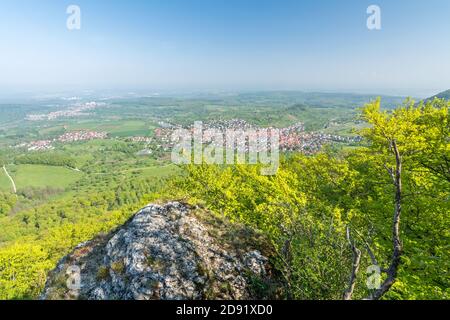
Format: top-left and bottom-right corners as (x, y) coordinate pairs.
(0, 99), (450, 299)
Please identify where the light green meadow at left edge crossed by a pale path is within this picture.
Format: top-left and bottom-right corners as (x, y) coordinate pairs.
(0, 165), (82, 191)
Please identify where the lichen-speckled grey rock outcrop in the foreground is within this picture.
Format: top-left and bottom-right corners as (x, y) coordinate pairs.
(42, 202), (268, 300)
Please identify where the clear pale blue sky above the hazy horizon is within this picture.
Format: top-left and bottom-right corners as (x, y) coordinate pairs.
(0, 0), (450, 97)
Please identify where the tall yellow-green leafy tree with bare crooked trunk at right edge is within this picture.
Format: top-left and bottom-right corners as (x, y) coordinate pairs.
(348, 99), (450, 299)
